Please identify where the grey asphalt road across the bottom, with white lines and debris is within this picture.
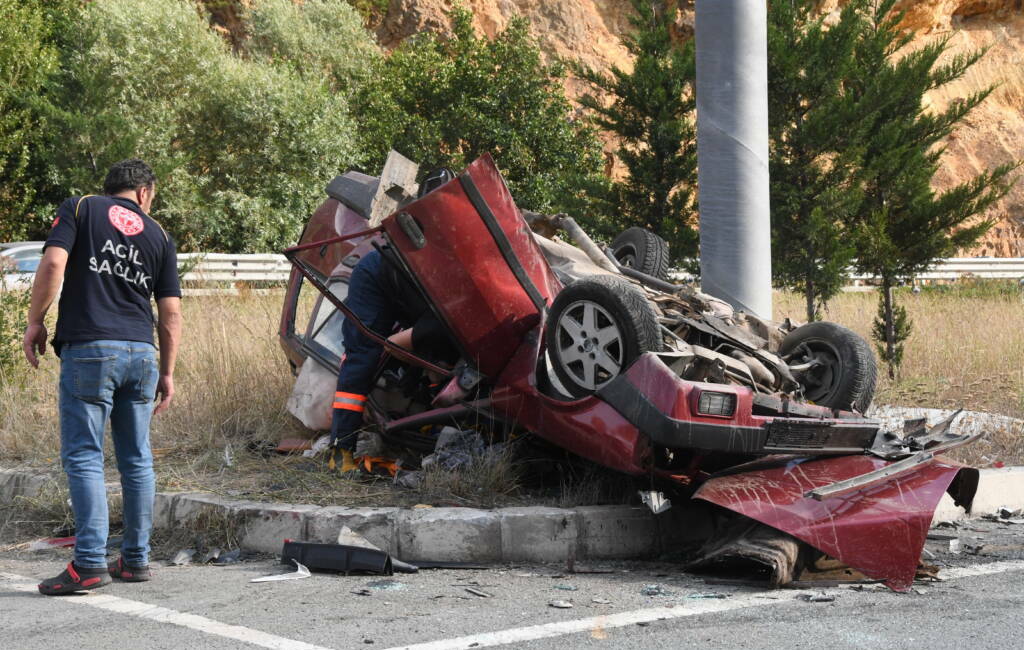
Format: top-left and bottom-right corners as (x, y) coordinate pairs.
(0, 523), (1024, 650)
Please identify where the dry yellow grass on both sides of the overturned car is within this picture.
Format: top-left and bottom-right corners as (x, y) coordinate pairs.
(0, 284), (1024, 513)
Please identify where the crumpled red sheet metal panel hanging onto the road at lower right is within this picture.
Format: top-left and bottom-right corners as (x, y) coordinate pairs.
(694, 456), (977, 591)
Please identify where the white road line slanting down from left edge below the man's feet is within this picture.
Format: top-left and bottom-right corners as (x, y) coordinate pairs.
(0, 573), (329, 650)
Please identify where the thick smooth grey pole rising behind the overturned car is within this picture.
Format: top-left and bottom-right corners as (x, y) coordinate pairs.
(695, 0), (772, 318)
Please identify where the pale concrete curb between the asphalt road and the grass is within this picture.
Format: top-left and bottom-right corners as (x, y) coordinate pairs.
(6, 467), (1024, 563)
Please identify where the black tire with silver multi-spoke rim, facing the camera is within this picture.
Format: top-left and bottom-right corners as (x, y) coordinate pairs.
(545, 275), (662, 397)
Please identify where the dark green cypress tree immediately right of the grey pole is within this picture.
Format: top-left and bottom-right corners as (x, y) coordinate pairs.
(768, 0), (865, 320)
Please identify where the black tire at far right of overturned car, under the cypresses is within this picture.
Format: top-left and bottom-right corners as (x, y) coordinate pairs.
(779, 320), (879, 413)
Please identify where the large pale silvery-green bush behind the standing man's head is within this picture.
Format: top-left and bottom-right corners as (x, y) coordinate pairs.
(38, 0), (372, 253)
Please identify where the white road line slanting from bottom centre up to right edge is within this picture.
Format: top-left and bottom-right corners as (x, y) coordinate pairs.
(389, 560), (1024, 650)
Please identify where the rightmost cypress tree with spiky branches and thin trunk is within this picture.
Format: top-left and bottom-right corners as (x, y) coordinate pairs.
(843, 0), (1017, 379)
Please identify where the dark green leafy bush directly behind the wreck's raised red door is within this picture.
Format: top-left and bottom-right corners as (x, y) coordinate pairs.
(357, 9), (602, 221)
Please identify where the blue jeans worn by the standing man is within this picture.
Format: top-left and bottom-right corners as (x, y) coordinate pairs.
(60, 341), (160, 568)
